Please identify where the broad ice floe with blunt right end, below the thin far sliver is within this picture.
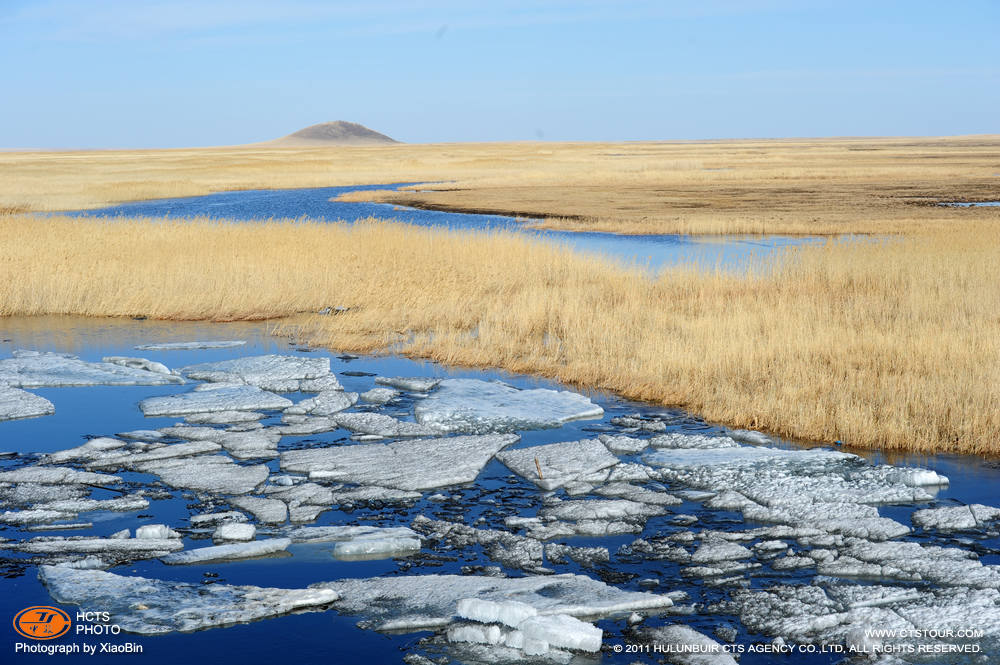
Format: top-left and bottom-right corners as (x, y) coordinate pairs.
(178, 355), (339, 392)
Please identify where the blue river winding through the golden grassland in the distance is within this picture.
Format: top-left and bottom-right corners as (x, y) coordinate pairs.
(62, 183), (823, 269)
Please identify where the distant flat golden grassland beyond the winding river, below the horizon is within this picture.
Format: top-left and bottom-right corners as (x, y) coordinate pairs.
(0, 136), (1000, 234)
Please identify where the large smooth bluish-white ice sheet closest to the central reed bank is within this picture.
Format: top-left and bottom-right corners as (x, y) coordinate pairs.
(414, 379), (604, 434)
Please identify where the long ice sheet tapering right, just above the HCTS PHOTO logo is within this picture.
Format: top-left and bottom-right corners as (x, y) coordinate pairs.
(38, 566), (337, 635)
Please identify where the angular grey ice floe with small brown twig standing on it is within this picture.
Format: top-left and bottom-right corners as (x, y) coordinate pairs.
(497, 439), (618, 490)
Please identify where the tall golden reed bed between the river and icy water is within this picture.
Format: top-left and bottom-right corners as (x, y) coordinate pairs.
(0, 215), (1000, 453)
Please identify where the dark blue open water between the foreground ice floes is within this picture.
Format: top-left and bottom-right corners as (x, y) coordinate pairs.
(0, 317), (1000, 665)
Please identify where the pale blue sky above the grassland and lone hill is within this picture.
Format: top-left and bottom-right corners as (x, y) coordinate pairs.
(0, 0), (1000, 148)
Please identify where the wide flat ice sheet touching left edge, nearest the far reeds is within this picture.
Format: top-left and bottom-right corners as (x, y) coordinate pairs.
(0, 350), (184, 388)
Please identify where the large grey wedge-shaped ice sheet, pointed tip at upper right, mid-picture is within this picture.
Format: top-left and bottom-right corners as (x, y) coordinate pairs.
(281, 434), (520, 491)
